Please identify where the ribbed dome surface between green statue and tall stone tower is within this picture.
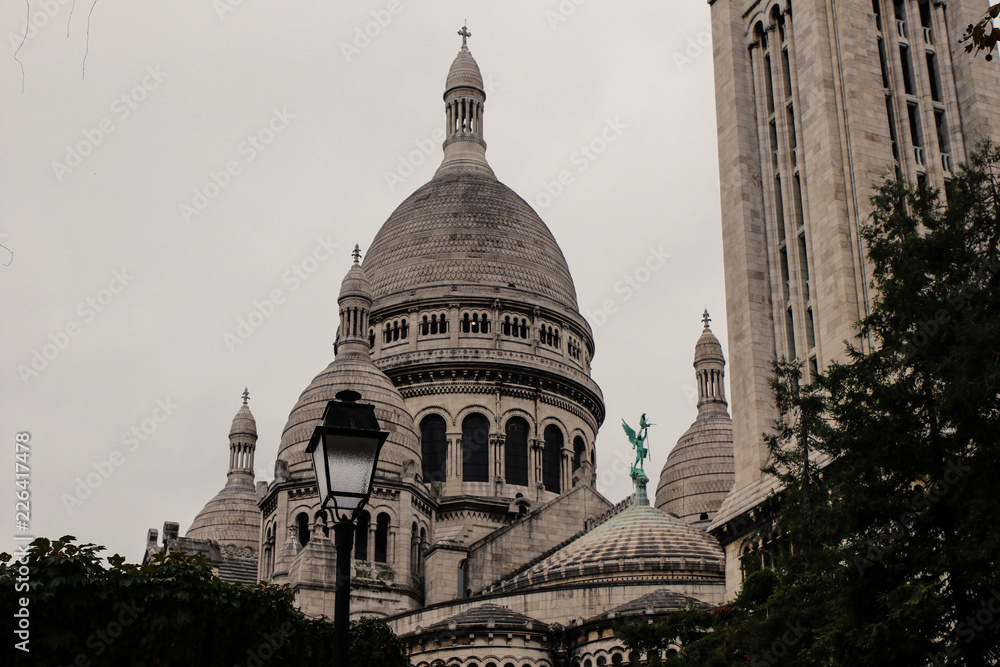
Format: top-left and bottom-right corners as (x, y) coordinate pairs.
(656, 410), (736, 523)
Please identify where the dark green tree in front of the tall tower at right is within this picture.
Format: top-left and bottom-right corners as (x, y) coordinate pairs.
(618, 144), (1000, 667)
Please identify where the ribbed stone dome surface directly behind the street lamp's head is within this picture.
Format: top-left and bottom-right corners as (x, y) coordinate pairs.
(278, 354), (420, 475)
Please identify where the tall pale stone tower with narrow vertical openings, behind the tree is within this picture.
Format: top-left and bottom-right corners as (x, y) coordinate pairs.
(709, 0), (1000, 592)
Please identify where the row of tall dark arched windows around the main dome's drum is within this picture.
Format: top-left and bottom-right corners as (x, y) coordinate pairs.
(420, 412), (586, 493)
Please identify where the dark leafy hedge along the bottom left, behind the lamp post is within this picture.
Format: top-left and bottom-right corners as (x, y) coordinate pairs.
(0, 536), (408, 667)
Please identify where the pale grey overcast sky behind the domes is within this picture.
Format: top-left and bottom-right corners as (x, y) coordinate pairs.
(0, 0), (727, 561)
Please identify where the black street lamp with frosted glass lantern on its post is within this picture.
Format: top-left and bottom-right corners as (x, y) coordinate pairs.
(306, 389), (389, 667)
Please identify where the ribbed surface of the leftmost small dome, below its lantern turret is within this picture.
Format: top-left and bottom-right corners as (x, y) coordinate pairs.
(186, 473), (260, 551)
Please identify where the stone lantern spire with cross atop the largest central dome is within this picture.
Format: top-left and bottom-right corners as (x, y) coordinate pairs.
(435, 26), (496, 178)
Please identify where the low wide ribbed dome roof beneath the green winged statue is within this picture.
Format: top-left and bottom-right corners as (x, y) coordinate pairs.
(498, 504), (724, 590)
